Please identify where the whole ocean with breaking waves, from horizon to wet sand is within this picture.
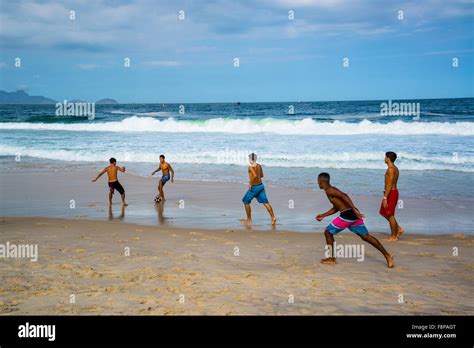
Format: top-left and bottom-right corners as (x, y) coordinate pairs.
(0, 98), (474, 201)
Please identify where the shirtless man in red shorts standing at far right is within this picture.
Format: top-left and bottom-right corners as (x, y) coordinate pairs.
(380, 151), (404, 241)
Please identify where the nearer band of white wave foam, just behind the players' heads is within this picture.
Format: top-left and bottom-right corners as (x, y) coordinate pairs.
(0, 145), (474, 173)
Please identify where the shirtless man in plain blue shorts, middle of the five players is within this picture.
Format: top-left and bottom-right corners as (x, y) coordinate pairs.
(240, 153), (276, 225)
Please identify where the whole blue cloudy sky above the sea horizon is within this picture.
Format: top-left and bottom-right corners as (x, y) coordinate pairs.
(0, 0), (474, 103)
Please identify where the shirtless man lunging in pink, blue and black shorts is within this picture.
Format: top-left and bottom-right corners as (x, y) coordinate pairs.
(316, 173), (393, 268)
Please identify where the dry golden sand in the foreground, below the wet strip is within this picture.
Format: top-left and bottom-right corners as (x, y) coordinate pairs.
(0, 217), (474, 315)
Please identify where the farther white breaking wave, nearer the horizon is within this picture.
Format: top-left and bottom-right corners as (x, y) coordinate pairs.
(0, 116), (474, 136)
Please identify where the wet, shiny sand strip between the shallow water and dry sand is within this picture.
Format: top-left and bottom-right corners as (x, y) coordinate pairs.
(0, 167), (474, 235)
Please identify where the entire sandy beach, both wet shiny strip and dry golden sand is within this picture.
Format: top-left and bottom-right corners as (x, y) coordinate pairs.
(0, 167), (474, 315)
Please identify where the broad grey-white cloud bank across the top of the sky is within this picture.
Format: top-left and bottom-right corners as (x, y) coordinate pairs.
(0, 0), (474, 62)
